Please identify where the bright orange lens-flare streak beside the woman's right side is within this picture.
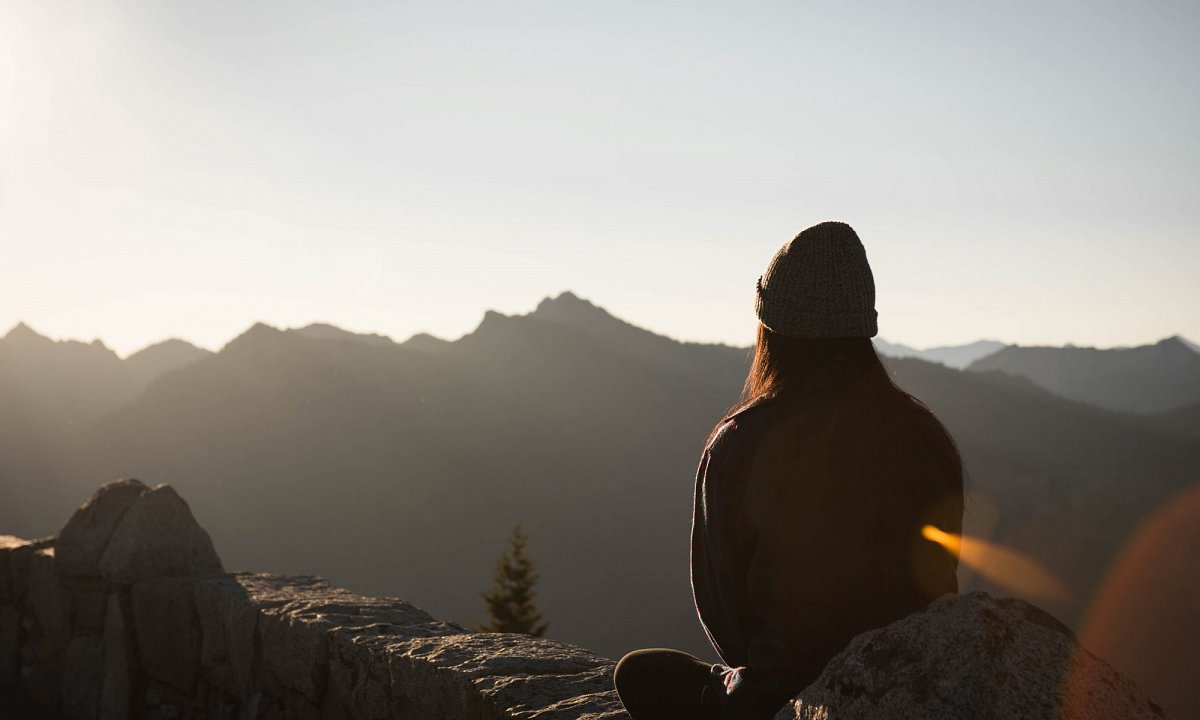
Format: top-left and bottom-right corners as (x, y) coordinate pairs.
(920, 526), (1070, 602)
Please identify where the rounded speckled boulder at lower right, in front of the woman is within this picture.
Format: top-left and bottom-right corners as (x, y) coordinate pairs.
(775, 593), (1163, 720)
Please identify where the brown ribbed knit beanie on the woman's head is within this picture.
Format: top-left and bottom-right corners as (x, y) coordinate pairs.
(755, 222), (878, 337)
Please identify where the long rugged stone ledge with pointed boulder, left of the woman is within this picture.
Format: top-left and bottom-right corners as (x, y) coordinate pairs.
(0, 480), (625, 720)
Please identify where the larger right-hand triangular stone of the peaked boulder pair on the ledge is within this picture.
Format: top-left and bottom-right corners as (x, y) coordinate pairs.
(100, 485), (223, 584)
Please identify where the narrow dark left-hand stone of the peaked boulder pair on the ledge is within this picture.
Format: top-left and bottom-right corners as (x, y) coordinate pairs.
(55, 479), (150, 577)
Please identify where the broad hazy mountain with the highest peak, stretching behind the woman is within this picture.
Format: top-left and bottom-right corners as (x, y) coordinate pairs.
(0, 293), (1200, 710)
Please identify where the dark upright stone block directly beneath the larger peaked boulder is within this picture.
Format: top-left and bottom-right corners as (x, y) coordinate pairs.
(131, 577), (200, 695)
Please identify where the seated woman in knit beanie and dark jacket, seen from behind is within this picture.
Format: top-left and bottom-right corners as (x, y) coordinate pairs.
(613, 222), (962, 720)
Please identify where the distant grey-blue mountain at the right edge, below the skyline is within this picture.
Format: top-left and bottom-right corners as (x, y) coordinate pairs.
(967, 336), (1200, 414)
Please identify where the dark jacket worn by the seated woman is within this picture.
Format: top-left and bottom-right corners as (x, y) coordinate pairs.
(691, 396), (962, 719)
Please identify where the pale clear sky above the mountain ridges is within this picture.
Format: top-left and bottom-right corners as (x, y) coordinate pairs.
(0, 0), (1200, 355)
